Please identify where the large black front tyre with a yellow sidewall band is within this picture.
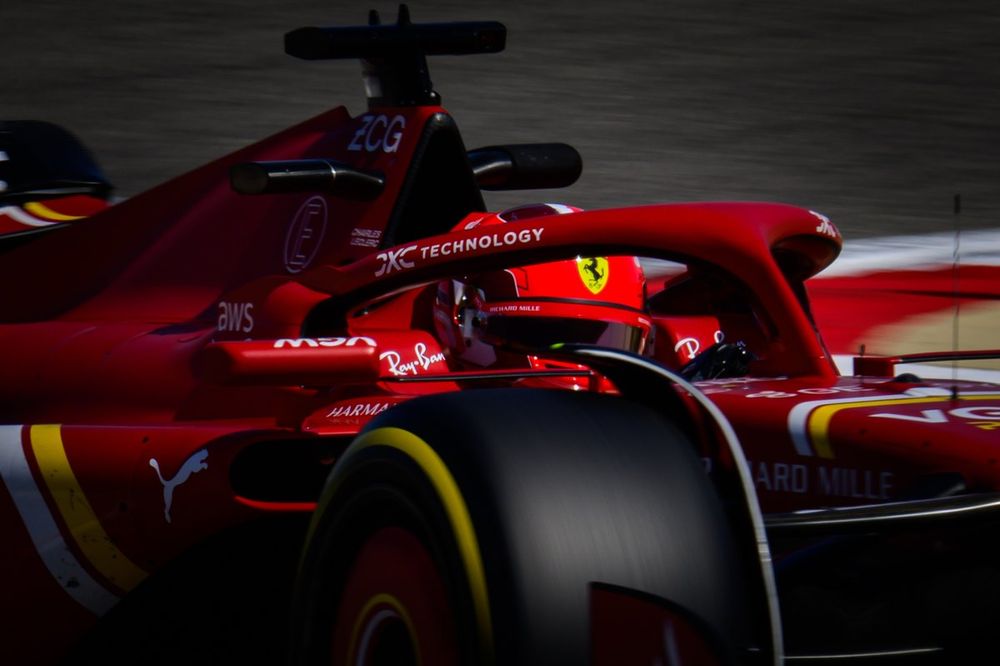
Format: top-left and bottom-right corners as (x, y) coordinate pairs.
(296, 389), (766, 664)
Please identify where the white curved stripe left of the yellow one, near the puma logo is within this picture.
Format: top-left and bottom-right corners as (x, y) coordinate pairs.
(0, 425), (118, 615)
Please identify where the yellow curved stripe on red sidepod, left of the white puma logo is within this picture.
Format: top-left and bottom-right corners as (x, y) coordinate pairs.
(31, 425), (146, 591)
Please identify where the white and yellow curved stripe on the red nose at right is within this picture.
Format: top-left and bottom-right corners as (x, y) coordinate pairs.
(788, 393), (1000, 458)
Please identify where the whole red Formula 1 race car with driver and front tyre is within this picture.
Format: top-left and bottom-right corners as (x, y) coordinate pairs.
(0, 9), (1000, 665)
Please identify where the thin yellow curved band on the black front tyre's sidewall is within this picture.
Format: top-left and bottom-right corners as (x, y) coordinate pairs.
(324, 427), (493, 658)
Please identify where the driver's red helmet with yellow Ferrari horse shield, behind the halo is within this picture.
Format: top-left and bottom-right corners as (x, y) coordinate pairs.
(434, 204), (652, 368)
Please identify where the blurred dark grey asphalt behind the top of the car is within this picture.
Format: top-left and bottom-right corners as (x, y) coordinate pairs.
(0, 0), (1000, 240)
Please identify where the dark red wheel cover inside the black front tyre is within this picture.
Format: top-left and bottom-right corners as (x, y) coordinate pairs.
(331, 527), (459, 666)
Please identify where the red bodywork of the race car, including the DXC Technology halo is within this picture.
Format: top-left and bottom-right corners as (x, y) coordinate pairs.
(0, 11), (1000, 663)
